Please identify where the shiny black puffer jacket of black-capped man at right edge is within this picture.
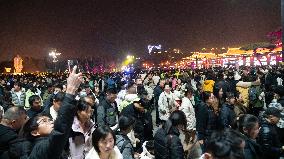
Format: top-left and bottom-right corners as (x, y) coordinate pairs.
(257, 117), (283, 159)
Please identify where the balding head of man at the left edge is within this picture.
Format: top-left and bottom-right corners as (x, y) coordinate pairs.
(1, 106), (28, 131)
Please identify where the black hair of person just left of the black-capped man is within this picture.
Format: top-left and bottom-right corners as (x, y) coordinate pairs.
(238, 114), (259, 134)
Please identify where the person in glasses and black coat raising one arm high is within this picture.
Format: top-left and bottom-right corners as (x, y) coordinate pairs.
(22, 66), (82, 159)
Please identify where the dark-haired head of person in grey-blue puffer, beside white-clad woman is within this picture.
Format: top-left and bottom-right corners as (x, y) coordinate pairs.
(118, 115), (135, 134)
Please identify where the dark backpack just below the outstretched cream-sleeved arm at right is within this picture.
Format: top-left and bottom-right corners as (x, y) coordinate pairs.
(249, 86), (264, 108)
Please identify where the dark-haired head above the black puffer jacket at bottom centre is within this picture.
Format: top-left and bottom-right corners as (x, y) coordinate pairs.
(169, 110), (187, 131)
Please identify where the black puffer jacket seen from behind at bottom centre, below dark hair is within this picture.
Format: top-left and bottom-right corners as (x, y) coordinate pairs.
(154, 120), (184, 159)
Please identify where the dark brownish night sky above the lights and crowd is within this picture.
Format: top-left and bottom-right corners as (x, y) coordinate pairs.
(0, 0), (281, 60)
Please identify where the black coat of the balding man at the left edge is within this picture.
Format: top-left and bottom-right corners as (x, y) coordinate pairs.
(0, 124), (18, 159)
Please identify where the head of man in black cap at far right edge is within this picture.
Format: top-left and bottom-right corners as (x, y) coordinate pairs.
(263, 107), (283, 124)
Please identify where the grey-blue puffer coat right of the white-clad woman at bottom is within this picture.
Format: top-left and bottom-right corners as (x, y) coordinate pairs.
(116, 132), (134, 159)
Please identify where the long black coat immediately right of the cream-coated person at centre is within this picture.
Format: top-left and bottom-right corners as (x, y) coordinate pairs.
(195, 102), (218, 140)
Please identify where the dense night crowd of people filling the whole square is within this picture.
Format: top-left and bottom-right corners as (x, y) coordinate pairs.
(0, 66), (284, 159)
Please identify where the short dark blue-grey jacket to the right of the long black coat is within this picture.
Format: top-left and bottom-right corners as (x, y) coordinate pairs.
(219, 103), (236, 129)
